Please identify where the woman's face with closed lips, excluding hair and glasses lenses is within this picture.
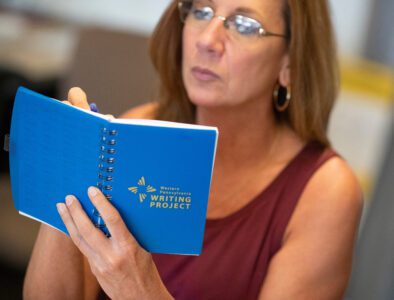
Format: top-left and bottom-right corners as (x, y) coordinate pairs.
(182, 0), (289, 107)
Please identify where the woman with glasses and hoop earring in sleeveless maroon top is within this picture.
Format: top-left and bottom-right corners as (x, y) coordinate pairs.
(24, 0), (362, 299)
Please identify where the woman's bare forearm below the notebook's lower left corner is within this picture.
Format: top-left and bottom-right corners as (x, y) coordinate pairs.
(23, 224), (99, 299)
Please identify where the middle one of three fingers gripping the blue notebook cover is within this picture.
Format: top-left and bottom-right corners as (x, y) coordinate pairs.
(66, 195), (108, 253)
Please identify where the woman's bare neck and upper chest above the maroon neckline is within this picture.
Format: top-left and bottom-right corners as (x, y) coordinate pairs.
(196, 99), (303, 218)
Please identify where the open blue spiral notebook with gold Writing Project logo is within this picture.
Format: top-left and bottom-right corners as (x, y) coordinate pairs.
(9, 87), (218, 255)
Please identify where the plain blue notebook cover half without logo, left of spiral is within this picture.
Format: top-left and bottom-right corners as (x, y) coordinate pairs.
(9, 88), (104, 232)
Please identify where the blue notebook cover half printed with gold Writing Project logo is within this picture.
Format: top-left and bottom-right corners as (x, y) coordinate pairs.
(107, 120), (217, 254)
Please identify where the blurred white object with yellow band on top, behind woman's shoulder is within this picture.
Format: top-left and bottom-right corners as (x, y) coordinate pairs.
(329, 59), (394, 200)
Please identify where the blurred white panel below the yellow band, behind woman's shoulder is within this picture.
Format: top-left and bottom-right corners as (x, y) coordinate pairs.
(328, 91), (392, 196)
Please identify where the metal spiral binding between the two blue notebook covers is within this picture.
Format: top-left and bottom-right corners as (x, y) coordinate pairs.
(93, 128), (118, 237)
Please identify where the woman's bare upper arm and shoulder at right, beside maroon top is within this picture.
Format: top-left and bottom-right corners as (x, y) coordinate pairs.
(259, 158), (362, 300)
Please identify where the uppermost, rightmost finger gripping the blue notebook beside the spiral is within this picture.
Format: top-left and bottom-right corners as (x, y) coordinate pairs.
(88, 187), (137, 247)
